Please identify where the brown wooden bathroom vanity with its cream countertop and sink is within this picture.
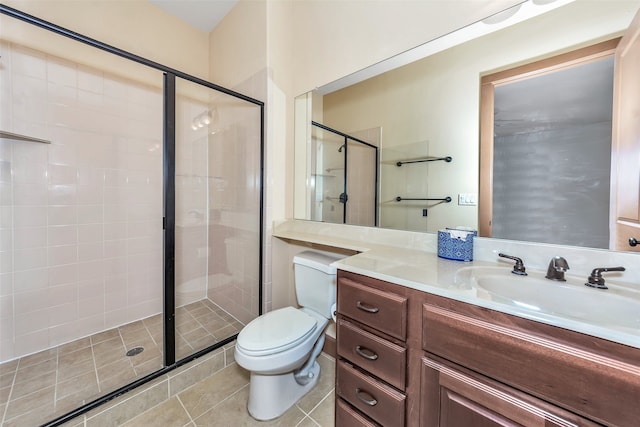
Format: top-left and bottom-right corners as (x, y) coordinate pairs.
(274, 221), (640, 427)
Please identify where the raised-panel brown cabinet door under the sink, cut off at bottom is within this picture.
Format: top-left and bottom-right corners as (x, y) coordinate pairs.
(420, 357), (596, 427)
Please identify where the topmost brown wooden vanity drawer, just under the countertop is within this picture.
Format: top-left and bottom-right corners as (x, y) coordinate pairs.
(338, 277), (407, 341)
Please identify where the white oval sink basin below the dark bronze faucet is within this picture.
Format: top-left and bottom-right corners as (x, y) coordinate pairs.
(456, 267), (640, 330)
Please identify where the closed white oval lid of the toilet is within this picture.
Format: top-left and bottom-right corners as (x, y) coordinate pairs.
(237, 307), (316, 354)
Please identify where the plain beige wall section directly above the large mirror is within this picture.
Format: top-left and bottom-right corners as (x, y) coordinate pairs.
(291, 0), (520, 95)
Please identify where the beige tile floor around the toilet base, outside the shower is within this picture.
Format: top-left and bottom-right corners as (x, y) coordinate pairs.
(123, 353), (335, 427)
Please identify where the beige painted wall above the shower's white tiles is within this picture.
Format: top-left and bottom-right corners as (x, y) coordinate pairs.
(0, 0), (209, 79)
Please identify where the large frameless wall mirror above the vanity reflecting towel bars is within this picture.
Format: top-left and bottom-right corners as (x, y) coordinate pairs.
(294, 0), (640, 252)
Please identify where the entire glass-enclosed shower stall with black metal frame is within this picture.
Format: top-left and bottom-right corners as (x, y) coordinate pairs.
(0, 5), (264, 425)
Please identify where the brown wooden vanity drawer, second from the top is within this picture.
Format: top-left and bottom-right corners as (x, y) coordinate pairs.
(338, 319), (406, 390)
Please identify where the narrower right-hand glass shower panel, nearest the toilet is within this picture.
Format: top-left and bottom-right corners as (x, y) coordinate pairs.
(175, 79), (261, 360)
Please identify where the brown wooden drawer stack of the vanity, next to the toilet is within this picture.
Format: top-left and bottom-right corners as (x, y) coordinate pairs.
(336, 271), (421, 427)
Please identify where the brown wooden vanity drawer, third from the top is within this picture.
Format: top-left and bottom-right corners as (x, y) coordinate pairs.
(336, 361), (406, 427)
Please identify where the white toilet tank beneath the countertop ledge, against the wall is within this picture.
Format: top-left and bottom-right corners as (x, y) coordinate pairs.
(293, 251), (345, 318)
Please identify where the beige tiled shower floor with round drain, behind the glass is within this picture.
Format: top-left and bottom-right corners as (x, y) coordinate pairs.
(0, 299), (242, 427)
